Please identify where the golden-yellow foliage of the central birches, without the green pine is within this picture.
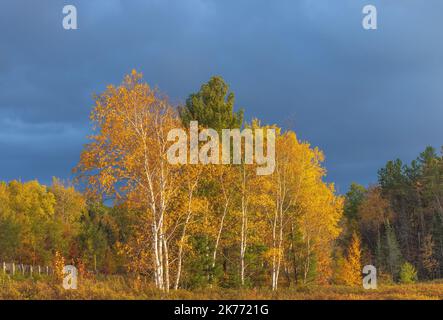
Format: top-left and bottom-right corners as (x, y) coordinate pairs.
(76, 70), (343, 281)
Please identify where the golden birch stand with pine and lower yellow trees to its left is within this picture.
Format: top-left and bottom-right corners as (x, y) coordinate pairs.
(0, 71), (343, 291)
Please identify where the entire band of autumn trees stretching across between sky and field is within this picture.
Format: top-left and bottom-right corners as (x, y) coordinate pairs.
(0, 70), (443, 298)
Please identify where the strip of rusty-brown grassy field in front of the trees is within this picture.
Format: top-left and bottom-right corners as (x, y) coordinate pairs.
(0, 276), (443, 300)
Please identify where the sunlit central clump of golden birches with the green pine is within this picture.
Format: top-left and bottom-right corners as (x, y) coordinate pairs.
(76, 71), (343, 290)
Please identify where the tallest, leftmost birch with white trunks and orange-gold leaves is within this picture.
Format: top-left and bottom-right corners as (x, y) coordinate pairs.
(76, 70), (181, 290)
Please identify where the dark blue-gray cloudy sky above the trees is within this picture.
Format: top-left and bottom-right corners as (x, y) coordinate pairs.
(0, 0), (443, 192)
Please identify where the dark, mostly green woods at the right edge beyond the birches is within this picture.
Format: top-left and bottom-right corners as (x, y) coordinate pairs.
(346, 147), (443, 281)
